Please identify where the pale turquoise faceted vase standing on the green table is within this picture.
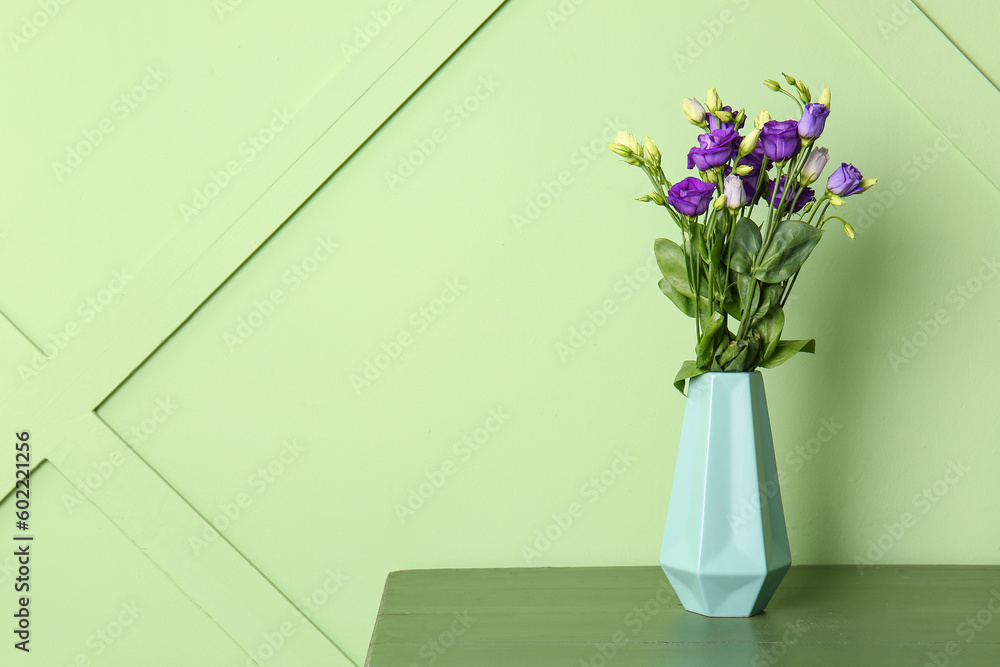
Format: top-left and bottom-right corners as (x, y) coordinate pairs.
(660, 371), (792, 616)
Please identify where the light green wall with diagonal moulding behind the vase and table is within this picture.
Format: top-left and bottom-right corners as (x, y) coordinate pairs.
(0, 0), (1000, 666)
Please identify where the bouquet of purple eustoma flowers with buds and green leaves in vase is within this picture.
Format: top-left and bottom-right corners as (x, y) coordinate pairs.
(608, 75), (877, 392)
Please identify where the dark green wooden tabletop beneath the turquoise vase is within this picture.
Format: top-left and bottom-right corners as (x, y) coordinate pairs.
(365, 565), (1000, 667)
